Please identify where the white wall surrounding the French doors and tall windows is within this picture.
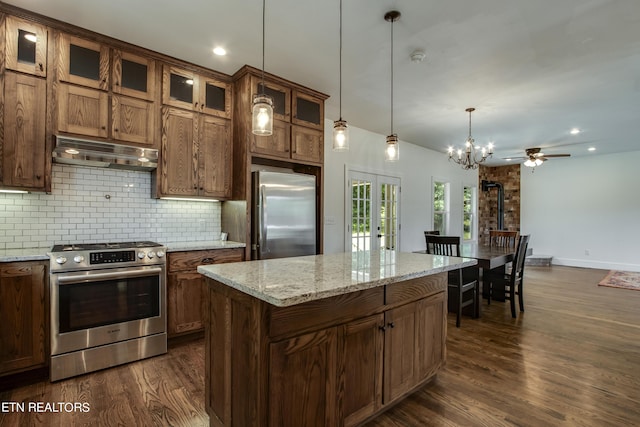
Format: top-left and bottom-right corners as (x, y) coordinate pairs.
(324, 120), (478, 253)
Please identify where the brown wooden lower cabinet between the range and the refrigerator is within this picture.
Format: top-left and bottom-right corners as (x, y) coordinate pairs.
(167, 248), (244, 338)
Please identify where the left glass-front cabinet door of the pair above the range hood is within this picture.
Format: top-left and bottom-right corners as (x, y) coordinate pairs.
(58, 34), (109, 91)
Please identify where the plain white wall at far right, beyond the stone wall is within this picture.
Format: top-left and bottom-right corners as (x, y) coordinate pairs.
(520, 151), (640, 271)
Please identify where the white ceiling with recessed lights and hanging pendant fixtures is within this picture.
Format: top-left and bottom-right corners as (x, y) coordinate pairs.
(6, 0), (640, 165)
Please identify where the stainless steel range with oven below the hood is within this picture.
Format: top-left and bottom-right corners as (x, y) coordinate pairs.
(49, 242), (167, 381)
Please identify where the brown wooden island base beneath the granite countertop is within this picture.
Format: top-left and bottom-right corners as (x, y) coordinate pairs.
(205, 273), (447, 426)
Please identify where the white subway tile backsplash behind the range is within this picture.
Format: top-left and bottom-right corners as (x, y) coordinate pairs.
(0, 163), (221, 249)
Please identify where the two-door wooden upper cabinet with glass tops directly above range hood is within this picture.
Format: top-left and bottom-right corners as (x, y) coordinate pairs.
(57, 34), (158, 146)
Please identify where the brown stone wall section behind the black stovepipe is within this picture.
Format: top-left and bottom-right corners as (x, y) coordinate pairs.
(478, 164), (520, 243)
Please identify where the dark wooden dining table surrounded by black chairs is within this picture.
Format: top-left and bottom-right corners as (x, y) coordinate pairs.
(415, 242), (531, 317)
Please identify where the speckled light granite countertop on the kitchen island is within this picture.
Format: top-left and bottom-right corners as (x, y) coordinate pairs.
(198, 251), (477, 307)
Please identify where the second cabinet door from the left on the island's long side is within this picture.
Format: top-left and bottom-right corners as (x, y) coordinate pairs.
(338, 314), (385, 427)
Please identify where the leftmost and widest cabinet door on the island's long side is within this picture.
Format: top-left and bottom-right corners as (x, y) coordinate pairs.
(269, 327), (338, 427)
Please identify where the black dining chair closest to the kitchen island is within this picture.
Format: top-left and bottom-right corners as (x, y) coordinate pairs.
(424, 233), (479, 328)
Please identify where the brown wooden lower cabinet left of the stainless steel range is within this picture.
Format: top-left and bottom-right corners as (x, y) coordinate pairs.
(0, 261), (47, 375)
